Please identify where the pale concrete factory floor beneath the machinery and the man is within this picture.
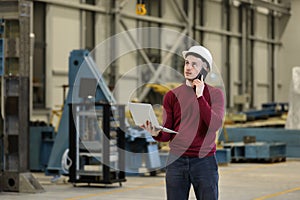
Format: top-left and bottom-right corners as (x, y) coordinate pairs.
(0, 159), (300, 200)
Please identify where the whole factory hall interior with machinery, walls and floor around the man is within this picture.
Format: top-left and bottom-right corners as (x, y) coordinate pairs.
(0, 0), (300, 200)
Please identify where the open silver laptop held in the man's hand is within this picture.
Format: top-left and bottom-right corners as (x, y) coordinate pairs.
(128, 103), (178, 134)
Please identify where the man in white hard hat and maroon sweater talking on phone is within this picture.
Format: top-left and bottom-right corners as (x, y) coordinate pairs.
(142, 46), (224, 200)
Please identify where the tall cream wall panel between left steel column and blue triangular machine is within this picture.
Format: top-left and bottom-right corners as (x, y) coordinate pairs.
(46, 5), (80, 108)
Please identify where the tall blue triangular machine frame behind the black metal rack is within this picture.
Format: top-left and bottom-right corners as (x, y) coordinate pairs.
(46, 50), (116, 175)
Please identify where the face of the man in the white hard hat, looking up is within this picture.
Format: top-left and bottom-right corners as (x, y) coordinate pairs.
(184, 55), (203, 80)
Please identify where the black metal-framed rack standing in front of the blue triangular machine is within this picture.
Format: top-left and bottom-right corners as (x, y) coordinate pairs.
(68, 103), (126, 186)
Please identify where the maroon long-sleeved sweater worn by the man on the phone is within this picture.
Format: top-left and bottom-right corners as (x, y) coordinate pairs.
(154, 84), (224, 157)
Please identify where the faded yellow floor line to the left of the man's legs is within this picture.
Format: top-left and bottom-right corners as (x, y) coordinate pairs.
(65, 181), (165, 200)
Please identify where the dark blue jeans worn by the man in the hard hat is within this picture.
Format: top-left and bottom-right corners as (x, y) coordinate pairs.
(166, 155), (219, 200)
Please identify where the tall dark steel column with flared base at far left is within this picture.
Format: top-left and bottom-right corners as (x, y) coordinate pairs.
(0, 0), (43, 193)
